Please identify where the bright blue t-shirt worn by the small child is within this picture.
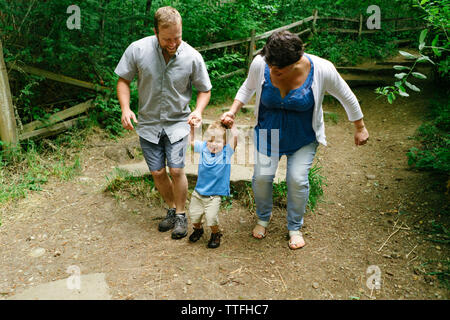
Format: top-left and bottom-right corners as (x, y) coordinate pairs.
(194, 141), (234, 196)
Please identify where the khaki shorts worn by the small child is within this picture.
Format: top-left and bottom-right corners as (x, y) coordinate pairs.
(189, 190), (222, 227)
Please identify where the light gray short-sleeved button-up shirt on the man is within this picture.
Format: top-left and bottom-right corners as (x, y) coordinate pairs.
(114, 36), (212, 143)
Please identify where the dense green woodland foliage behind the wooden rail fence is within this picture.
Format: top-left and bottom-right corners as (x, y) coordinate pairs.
(0, 0), (424, 127)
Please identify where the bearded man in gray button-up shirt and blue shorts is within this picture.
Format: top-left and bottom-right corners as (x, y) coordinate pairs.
(114, 7), (212, 239)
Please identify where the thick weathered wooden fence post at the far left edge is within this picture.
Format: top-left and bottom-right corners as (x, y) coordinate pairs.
(0, 40), (18, 149)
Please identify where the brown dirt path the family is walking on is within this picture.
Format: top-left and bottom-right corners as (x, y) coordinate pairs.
(0, 82), (450, 299)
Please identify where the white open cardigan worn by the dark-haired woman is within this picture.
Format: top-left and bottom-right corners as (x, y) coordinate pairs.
(235, 54), (363, 146)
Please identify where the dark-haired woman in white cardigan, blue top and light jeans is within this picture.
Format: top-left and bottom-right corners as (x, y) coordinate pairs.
(221, 31), (369, 249)
